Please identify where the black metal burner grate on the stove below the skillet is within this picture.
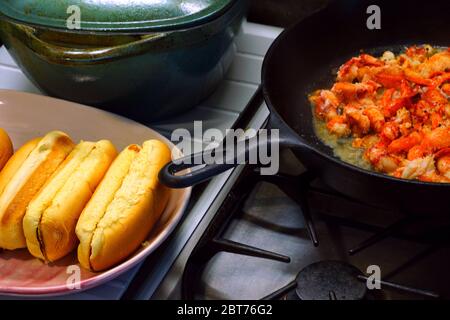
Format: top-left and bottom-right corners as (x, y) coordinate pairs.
(182, 162), (450, 300)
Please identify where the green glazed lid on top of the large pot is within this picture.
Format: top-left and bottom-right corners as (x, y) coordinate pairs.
(0, 0), (237, 32)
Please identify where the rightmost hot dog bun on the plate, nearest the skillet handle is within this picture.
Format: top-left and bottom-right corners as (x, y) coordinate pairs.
(76, 140), (171, 271)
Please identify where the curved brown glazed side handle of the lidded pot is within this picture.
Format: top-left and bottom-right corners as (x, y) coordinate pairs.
(14, 24), (168, 63)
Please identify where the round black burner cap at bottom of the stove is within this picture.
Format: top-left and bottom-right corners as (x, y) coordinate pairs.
(296, 261), (367, 300)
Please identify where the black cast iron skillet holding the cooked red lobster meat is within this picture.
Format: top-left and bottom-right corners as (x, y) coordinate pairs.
(160, 0), (450, 215)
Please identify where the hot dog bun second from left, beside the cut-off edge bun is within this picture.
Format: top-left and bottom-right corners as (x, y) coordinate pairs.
(0, 131), (74, 250)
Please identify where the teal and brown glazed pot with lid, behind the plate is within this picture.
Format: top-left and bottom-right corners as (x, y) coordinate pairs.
(0, 0), (247, 122)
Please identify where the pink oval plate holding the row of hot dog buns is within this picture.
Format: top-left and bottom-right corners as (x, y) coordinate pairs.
(0, 90), (191, 296)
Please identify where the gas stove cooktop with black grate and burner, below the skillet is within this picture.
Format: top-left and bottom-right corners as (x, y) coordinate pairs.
(169, 150), (450, 300)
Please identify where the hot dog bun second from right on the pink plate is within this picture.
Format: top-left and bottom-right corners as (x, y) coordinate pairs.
(23, 140), (117, 261)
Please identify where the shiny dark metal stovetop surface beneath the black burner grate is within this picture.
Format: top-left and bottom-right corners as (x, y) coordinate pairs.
(183, 150), (450, 299)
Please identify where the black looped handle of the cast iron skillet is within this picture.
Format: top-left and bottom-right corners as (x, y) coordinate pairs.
(159, 135), (268, 188)
